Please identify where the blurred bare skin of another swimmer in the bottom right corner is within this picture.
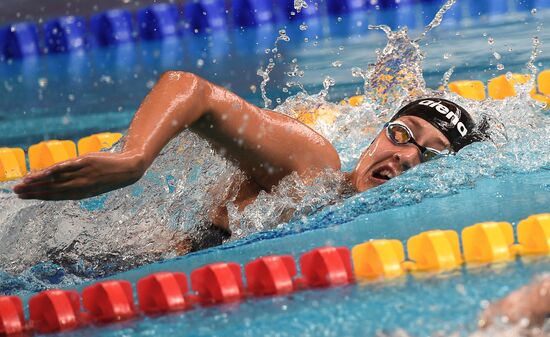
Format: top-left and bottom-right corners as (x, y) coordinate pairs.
(480, 275), (550, 327)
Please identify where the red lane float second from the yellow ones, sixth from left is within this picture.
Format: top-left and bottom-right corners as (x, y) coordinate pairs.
(244, 255), (296, 296)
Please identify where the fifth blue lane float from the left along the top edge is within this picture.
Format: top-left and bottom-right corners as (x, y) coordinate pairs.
(183, 0), (227, 32)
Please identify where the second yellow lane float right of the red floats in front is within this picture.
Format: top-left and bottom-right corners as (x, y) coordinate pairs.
(406, 230), (462, 271)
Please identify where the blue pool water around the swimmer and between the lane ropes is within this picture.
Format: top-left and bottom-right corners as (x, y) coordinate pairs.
(0, 0), (550, 336)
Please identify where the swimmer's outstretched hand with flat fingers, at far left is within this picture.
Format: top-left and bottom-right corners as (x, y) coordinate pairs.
(13, 152), (146, 200)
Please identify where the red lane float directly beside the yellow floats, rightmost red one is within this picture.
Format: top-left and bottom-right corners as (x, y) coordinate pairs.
(300, 247), (353, 287)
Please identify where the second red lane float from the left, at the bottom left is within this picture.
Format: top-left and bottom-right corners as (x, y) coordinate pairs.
(29, 290), (80, 333)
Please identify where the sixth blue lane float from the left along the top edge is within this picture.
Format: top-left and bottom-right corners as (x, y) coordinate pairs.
(233, 0), (275, 27)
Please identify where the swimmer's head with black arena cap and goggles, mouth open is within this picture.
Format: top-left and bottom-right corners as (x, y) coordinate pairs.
(351, 98), (487, 192)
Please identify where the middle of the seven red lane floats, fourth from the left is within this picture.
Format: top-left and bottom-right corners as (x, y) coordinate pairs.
(137, 273), (191, 314)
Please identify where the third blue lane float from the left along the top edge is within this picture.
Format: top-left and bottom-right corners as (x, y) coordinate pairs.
(90, 9), (133, 46)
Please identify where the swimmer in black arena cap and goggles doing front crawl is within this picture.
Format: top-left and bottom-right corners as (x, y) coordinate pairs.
(13, 71), (483, 233)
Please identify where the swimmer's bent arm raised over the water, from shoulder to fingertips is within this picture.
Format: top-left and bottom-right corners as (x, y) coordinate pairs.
(14, 71), (340, 200)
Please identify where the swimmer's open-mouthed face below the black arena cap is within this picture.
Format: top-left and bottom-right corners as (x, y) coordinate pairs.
(351, 116), (450, 192)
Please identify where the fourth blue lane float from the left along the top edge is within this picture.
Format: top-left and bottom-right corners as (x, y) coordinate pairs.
(137, 4), (179, 40)
